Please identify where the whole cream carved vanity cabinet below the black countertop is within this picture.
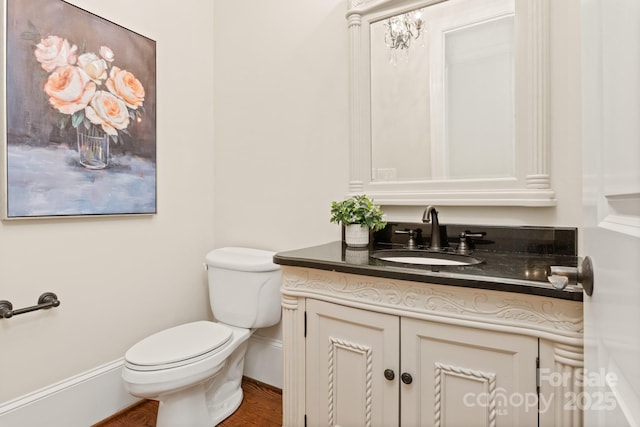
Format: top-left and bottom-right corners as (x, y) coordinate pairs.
(282, 266), (583, 427)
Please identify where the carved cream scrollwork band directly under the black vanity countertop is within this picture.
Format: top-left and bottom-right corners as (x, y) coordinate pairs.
(282, 266), (584, 346)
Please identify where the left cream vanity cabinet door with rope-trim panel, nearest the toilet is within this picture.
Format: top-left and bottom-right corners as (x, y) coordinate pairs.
(300, 300), (400, 427)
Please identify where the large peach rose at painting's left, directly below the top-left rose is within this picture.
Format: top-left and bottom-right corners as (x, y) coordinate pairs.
(44, 65), (96, 115)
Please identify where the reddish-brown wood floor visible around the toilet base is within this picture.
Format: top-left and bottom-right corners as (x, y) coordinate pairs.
(93, 377), (282, 427)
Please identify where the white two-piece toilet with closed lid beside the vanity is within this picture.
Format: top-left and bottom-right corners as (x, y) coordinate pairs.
(122, 247), (281, 427)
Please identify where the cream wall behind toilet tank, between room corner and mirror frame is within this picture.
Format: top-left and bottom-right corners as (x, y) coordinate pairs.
(214, 0), (349, 251)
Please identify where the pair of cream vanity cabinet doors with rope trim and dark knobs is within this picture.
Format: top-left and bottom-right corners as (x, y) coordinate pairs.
(305, 299), (538, 427)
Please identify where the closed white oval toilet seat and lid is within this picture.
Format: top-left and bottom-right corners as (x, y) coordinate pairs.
(125, 321), (233, 371)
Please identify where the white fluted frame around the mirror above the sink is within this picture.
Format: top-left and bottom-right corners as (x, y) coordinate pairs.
(347, 0), (556, 207)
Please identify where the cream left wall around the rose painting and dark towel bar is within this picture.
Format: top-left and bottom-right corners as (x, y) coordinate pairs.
(0, 0), (214, 402)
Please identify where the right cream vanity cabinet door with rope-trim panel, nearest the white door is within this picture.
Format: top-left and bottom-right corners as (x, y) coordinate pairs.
(400, 318), (538, 427)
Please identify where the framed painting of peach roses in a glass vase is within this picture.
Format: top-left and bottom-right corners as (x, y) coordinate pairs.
(2, 0), (157, 219)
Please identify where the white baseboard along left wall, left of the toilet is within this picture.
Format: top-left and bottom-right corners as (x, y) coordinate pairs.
(0, 358), (140, 427)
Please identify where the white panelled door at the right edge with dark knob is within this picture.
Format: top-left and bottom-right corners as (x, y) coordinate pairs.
(574, 0), (640, 426)
